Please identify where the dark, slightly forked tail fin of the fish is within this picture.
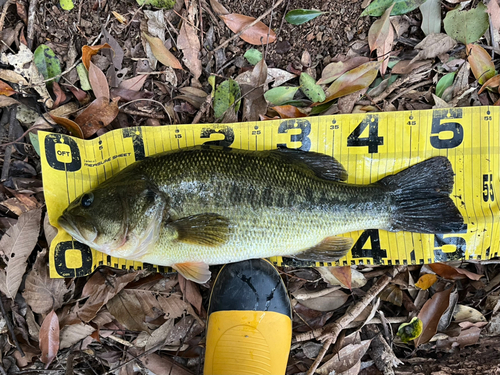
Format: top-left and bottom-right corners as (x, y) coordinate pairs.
(378, 156), (464, 233)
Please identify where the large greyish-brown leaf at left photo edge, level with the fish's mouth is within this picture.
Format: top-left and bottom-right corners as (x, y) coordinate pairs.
(0, 208), (42, 299)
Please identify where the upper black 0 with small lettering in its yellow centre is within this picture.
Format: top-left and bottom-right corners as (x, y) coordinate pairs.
(45, 134), (82, 172)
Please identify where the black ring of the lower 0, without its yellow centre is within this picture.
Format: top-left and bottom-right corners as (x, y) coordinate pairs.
(54, 241), (92, 277)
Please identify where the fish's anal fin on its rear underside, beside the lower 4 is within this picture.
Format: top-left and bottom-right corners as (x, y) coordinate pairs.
(294, 236), (354, 262)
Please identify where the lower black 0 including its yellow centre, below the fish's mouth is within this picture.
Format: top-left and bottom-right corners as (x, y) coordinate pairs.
(53, 241), (93, 277)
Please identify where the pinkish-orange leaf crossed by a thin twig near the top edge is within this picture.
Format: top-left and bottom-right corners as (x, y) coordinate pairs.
(219, 13), (276, 46)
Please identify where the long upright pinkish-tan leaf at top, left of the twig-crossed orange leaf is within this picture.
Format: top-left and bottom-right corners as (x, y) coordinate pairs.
(177, 2), (202, 80)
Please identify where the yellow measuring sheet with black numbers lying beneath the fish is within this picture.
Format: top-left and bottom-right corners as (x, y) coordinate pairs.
(39, 107), (500, 277)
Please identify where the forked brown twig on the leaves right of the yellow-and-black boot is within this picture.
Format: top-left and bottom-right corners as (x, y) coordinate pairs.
(296, 266), (406, 375)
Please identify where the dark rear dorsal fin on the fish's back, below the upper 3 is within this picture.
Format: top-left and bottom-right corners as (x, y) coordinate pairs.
(271, 148), (347, 181)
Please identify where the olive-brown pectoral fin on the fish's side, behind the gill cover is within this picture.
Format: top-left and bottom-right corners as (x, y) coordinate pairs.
(167, 214), (230, 246)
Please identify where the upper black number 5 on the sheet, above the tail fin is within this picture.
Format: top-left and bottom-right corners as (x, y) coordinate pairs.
(430, 108), (464, 149)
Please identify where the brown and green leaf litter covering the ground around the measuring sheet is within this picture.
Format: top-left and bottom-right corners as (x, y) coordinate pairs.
(0, 0), (500, 374)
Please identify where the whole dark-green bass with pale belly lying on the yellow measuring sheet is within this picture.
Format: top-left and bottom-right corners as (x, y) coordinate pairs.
(58, 146), (464, 283)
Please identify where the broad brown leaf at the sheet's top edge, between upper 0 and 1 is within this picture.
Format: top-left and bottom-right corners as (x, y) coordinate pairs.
(75, 96), (119, 138)
